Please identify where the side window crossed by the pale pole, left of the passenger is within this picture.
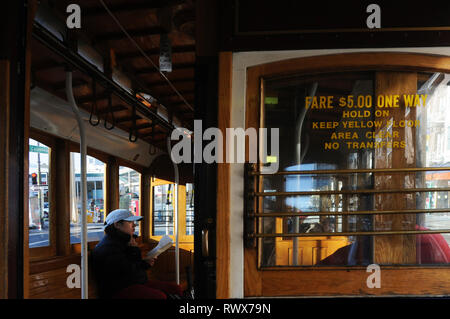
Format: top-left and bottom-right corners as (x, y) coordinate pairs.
(70, 152), (106, 244)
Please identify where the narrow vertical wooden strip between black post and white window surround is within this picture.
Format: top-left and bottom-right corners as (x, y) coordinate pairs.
(216, 52), (233, 299)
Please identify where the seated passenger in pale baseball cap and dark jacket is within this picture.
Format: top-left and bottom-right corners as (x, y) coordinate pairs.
(92, 209), (182, 299)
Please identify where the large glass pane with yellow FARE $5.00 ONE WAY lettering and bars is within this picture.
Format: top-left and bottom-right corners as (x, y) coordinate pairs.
(258, 72), (450, 267)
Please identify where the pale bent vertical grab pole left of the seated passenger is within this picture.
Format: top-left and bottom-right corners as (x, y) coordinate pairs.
(66, 71), (88, 299)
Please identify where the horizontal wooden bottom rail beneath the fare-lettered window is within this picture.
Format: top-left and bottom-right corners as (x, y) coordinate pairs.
(261, 266), (450, 297)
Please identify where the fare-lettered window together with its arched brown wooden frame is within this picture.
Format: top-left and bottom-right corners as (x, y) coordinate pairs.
(241, 52), (450, 296)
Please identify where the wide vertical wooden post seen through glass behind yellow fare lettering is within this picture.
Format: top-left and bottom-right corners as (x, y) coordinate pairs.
(374, 72), (417, 264)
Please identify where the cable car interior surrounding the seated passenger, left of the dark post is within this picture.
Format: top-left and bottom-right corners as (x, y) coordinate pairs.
(23, 1), (195, 298)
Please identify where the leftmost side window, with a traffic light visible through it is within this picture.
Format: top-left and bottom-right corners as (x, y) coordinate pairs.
(28, 138), (51, 248)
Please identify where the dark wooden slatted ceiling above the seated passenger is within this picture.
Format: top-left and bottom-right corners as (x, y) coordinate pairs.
(31, 0), (196, 149)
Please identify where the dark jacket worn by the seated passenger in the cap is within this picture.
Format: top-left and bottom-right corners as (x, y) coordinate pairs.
(92, 232), (150, 298)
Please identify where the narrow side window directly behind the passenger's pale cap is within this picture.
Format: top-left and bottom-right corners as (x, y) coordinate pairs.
(119, 166), (141, 234)
